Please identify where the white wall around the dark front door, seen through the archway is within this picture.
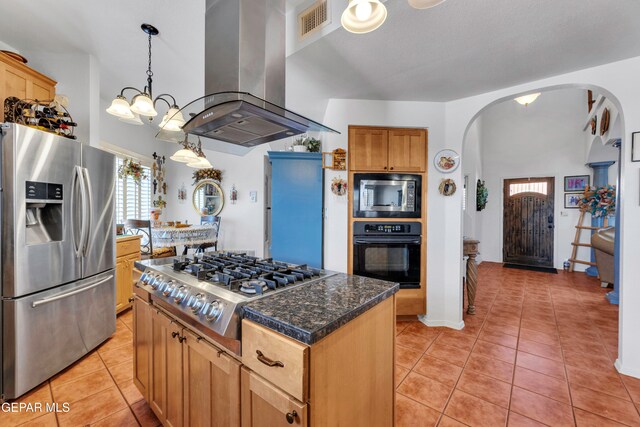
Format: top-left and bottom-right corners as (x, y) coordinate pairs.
(476, 89), (592, 271)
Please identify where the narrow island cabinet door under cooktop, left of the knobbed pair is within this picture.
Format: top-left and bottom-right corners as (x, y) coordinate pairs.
(149, 310), (183, 427)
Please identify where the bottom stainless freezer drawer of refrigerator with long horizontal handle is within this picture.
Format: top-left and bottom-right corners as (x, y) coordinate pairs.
(2, 270), (116, 399)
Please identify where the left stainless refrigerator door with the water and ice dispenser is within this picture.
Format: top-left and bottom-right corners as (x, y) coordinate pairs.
(0, 124), (82, 298)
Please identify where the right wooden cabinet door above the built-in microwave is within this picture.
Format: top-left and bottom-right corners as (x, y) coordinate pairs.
(389, 129), (427, 172)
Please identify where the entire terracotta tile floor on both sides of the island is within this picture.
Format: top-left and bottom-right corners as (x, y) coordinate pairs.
(5, 263), (640, 427)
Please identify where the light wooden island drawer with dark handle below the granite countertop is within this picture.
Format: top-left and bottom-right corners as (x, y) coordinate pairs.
(242, 319), (309, 402)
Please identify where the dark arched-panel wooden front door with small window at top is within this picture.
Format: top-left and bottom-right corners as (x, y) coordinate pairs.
(503, 178), (555, 267)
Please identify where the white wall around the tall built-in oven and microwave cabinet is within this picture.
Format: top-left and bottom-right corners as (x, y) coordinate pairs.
(322, 99), (444, 272)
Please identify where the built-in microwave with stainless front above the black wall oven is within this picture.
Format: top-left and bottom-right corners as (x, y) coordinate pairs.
(353, 173), (422, 218)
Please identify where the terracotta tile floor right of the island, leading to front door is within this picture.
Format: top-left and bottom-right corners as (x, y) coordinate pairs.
(396, 263), (640, 427)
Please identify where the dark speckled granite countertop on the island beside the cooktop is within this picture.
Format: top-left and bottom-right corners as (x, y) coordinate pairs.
(243, 274), (399, 345)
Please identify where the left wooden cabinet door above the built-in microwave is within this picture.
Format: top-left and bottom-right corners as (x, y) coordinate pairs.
(349, 128), (388, 172)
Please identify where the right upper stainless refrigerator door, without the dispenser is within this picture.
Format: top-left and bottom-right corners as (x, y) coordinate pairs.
(82, 145), (116, 277)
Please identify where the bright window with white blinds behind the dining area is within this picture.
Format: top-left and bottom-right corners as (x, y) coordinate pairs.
(116, 157), (153, 224)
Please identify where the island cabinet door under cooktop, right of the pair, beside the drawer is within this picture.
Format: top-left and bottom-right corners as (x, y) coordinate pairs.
(182, 331), (240, 427)
